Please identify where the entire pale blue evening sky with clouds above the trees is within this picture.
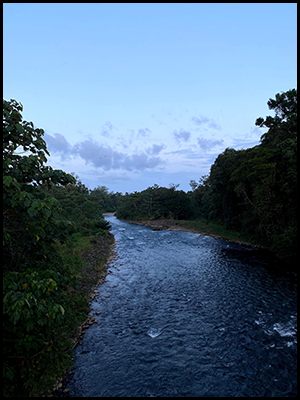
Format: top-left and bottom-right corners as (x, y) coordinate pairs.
(3, 3), (297, 193)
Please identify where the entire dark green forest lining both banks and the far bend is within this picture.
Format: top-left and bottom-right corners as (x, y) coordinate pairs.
(3, 89), (297, 396)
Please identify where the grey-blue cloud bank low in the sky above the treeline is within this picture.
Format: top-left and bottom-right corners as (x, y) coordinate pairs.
(44, 115), (258, 192)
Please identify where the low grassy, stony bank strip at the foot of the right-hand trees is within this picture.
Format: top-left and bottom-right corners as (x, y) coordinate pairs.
(121, 219), (263, 248)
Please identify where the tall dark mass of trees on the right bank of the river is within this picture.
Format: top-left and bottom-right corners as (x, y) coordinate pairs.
(191, 89), (297, 262)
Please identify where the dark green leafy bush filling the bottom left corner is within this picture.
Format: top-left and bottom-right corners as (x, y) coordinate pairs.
(3, 269), (71, 396)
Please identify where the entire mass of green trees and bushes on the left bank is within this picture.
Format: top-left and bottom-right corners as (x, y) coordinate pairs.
(3, 100), (109, 396)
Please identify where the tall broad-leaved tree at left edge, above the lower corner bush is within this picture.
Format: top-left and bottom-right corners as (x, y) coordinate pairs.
(3, 100), (74, 270)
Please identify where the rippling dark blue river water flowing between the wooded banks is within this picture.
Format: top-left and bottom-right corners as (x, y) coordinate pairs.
(68, 215), (297, 397)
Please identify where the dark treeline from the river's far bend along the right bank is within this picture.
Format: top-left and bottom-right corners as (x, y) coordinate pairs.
(102, 89), (297, 261)
